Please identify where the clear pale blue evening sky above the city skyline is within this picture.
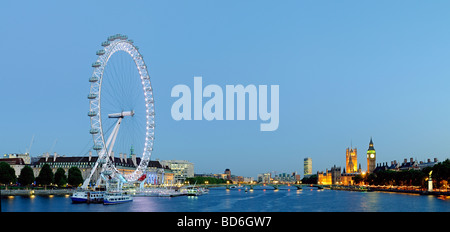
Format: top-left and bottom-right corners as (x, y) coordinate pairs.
(0, 0), (450, 177)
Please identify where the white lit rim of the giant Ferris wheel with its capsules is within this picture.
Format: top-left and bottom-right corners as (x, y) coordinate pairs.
(88, 34), (155, 181)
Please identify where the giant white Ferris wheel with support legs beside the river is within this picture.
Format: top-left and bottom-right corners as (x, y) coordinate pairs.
(82, 34), (155, 189)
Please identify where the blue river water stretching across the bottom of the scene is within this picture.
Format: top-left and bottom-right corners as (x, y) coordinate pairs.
(1, 187), (450, 212)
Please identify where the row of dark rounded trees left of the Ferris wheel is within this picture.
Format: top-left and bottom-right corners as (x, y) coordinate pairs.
(0, 162), (83, 187)
